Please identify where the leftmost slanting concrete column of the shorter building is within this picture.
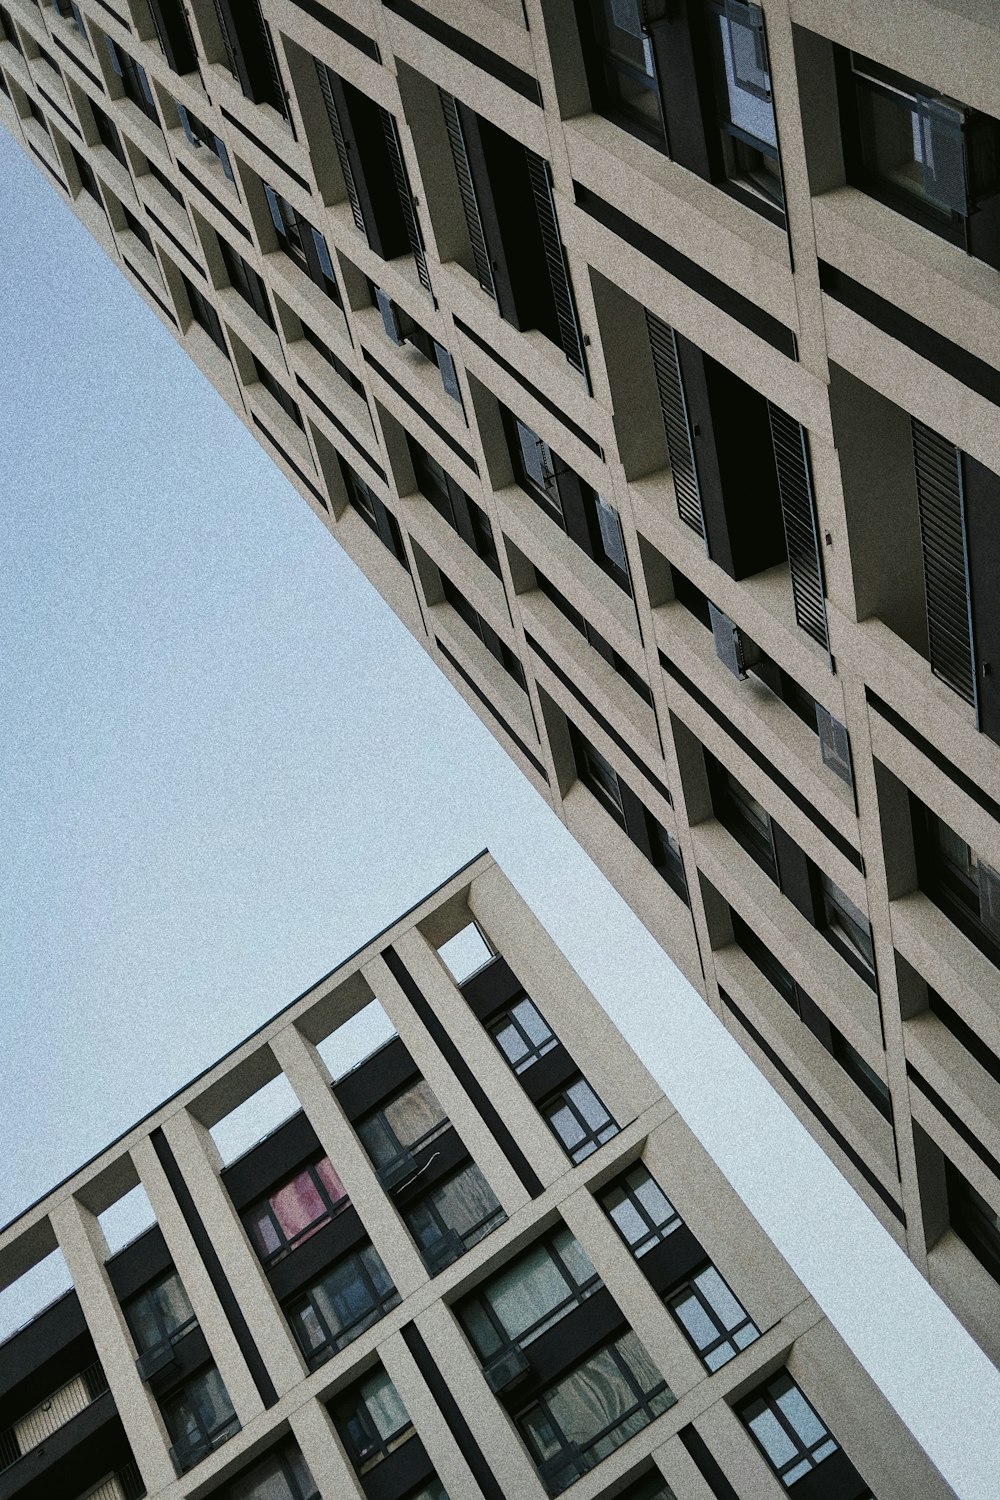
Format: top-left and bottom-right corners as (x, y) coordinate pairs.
(51, 1199), (174, 1494)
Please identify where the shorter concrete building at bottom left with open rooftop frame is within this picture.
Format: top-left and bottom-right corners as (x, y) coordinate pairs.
(0, 854), (954, 1500)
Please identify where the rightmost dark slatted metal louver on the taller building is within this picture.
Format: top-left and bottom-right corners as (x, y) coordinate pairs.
(910, 417), (976, 705)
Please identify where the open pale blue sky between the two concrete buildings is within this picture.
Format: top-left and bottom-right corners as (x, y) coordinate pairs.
(0, 131), (1000, 1500)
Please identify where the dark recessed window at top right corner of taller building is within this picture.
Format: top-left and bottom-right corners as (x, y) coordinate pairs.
(837, 48), (1000, 266)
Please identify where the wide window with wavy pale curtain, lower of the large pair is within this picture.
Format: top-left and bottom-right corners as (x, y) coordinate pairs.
(517, 1331), (676, 1494)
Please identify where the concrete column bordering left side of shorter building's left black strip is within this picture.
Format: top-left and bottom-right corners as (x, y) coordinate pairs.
(132, 1136), (264, 1427)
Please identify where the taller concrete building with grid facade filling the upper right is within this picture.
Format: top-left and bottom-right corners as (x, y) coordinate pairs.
(0, 0), (1000, 1361)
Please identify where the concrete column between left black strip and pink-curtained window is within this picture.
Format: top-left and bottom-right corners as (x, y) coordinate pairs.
(156, 1110), (304, 1397)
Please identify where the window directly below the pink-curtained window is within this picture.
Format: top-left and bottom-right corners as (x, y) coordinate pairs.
(286, 1245), (399, 1370)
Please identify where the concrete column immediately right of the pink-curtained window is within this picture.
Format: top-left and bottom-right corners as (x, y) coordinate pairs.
(271, 1026), (427, 1298)
